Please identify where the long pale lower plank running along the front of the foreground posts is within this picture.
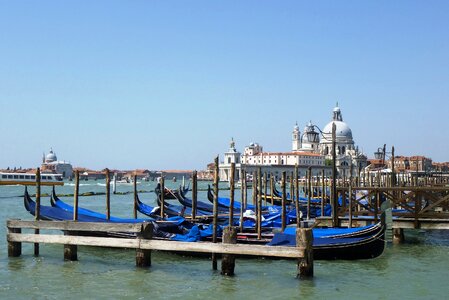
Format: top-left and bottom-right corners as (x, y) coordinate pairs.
(7, 233), (304, 258)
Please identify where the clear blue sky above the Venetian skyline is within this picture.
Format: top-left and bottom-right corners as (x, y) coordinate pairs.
(0, 0), (449, 169)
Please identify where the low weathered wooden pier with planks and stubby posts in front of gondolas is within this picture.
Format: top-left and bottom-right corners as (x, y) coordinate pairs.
(6, 220), (313, 278)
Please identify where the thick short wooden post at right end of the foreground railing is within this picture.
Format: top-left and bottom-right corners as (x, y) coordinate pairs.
(296, 228), (313, 279)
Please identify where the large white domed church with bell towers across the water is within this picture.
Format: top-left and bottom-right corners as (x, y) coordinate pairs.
(292, 103), (367, 176)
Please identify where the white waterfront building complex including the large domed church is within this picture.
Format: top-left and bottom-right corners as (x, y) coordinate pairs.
(220, 103), (367, 181)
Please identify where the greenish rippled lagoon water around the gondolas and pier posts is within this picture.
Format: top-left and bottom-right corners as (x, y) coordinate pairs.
(0, 181), (449, 299)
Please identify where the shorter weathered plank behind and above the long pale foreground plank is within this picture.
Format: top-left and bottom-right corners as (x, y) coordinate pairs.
(6, 220), (142, 232)
